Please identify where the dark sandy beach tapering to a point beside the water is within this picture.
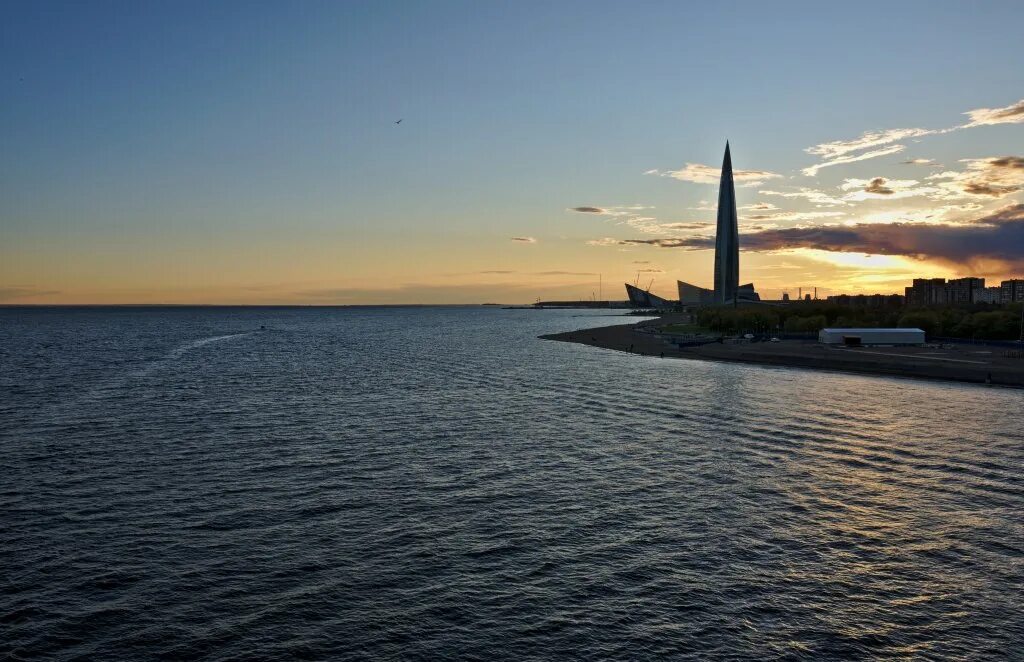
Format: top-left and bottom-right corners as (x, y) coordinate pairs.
(539, 318), (1024, 388)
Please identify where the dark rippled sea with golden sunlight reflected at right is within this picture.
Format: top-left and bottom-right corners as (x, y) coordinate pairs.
(0, 308), (1024, 660)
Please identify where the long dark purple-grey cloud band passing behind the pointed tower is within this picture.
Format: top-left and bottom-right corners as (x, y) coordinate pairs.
(585, 204), (1024, 268)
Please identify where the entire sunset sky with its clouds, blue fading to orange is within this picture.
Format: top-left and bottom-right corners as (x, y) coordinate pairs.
(0, 0), (1024, 304)
